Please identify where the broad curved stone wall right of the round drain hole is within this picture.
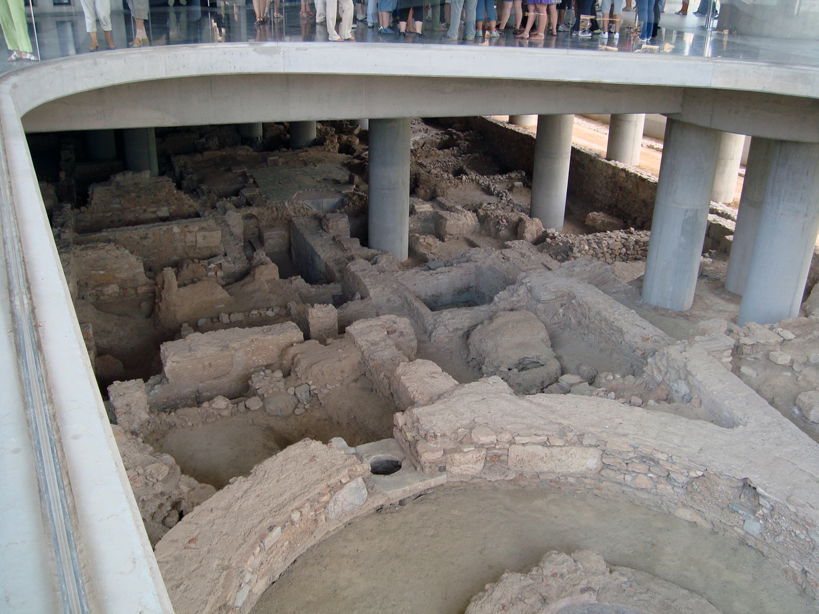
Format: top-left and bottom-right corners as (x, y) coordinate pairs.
(395, 380), (819, 596)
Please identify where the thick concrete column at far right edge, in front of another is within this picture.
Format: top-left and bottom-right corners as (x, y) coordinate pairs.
(739, 141), (819, 324)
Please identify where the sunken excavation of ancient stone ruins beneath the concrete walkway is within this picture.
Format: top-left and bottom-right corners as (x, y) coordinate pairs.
(28, 116), (819, 614)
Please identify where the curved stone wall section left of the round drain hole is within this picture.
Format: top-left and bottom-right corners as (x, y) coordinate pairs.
(150, 439), (438, 614)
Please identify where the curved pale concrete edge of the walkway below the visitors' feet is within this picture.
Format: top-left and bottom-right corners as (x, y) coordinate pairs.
(4, 43), (819, 142)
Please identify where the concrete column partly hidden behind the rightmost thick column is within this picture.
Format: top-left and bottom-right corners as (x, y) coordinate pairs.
(725, 136), (772, 295)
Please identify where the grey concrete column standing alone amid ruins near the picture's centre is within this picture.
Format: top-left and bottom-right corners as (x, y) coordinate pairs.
(367, 119), (410, 260)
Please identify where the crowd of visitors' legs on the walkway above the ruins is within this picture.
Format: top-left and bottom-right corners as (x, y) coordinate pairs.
(0, 0), (700, 62)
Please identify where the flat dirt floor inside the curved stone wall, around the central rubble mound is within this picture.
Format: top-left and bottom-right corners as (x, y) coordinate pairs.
(252, 483), (815, 614)
